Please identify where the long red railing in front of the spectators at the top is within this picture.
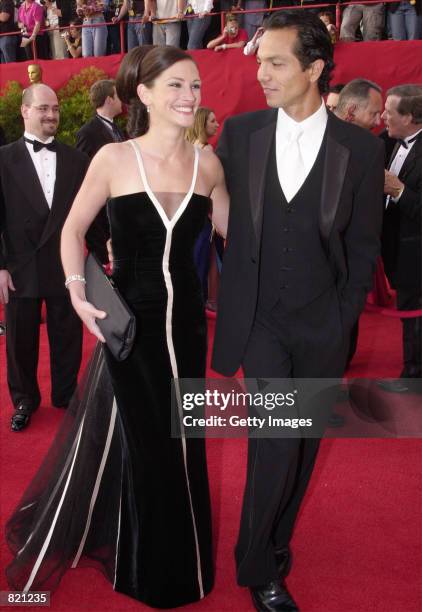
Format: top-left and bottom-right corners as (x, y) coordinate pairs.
(0, 0), (408, 60)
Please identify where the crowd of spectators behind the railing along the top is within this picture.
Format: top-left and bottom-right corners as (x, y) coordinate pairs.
(0, 0), (422, 62)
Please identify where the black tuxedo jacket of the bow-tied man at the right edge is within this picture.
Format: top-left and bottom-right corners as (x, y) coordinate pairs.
(382, 132), (422, 292)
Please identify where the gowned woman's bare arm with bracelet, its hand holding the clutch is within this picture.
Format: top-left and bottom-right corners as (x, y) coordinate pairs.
(61, 144), (116, 342)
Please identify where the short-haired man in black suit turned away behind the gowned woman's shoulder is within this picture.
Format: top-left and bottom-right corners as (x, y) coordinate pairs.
(76, 79), (125, 263)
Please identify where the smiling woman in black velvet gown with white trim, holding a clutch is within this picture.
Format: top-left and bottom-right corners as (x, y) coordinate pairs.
(7, 47), (228, 608)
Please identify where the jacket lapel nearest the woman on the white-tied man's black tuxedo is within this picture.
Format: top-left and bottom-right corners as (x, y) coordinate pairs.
(249, 111), (277, 256)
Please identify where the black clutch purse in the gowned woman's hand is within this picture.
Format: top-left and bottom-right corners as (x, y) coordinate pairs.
(85, 253), (136, 361)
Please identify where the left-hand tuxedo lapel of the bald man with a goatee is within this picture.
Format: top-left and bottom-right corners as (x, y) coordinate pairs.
(10, 138), (50, 216)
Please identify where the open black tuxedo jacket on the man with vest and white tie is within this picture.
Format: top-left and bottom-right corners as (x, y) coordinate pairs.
(212, 109), (384, 376)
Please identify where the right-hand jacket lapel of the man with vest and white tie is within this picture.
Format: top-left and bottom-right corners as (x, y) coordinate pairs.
(319, 113), (350, 242)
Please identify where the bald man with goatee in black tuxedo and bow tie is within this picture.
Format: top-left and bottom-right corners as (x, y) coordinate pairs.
(0, 84), (88, 431)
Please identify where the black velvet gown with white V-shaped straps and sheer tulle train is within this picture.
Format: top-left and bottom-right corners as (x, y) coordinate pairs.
(7, 142), (213, 608)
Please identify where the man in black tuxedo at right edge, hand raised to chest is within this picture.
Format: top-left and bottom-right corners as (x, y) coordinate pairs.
(378, 85), (422, 393)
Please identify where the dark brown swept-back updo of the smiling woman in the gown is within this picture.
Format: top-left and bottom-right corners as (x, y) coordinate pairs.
(116, 45), (195, 138)
